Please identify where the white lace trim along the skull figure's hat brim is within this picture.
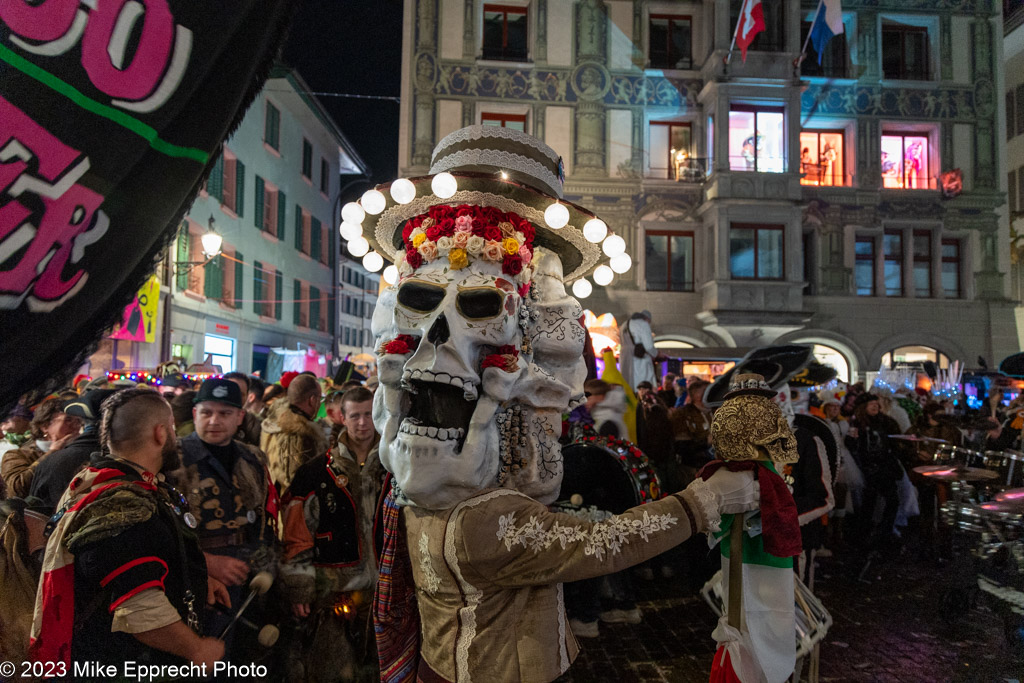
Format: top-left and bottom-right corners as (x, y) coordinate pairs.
(367, 189), (602, 283)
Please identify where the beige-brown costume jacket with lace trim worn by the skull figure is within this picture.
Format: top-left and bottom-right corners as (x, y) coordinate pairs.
(402, 486), (718, 683)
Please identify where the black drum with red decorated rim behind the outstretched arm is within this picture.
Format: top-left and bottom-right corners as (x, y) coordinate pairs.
(558, 436), (662, 514)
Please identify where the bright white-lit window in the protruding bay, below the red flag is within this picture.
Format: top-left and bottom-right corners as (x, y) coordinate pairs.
(729, 104), (785, 173)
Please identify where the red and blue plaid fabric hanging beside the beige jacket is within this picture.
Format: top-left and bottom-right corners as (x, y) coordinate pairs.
(374, 490), (420, 683)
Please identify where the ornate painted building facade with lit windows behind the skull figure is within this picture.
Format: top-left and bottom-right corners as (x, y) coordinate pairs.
(399, 0), (1019, 376)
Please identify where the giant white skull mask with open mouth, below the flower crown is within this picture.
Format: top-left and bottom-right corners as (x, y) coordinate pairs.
(373, 248), (586, 509)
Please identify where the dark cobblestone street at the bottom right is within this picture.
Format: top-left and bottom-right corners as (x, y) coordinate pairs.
(561, 555), (1024, 683)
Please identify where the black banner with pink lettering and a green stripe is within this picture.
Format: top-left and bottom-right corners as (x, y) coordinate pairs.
(0, 0), (296, 405)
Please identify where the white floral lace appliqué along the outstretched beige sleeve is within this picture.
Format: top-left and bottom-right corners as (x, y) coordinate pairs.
(496, 511), (679, 561)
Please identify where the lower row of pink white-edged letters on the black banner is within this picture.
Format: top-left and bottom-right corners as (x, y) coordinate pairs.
(0, 97), (110, 311)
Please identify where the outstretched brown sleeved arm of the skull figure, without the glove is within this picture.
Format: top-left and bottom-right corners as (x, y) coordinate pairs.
(460, 481), (718, 588)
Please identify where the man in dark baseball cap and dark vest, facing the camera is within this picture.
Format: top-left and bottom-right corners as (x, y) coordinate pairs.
(168, 378), (278, 660)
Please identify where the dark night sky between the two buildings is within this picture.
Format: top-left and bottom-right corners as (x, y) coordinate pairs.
(283, 0), (402, 192)
